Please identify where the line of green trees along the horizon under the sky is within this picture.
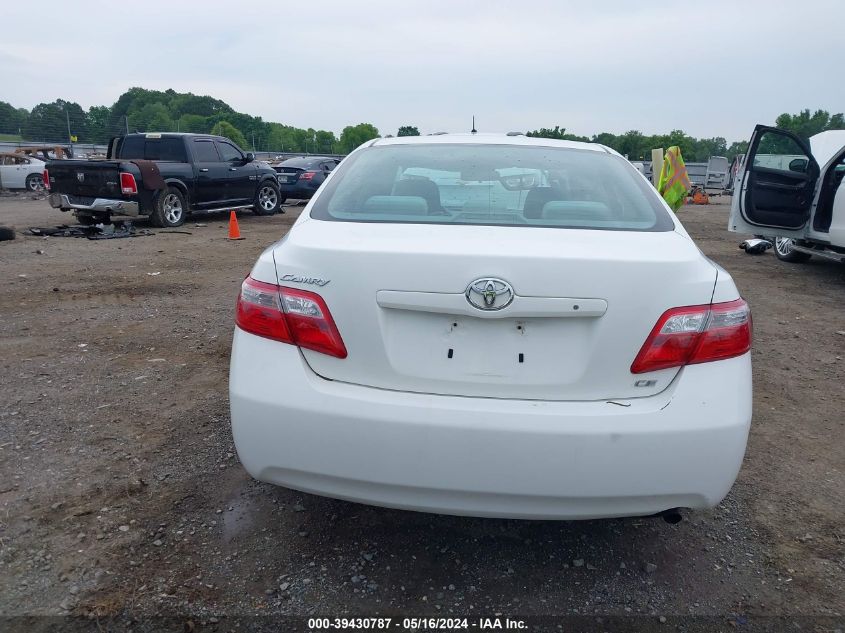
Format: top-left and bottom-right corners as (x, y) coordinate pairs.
(0, 88), (845, 162)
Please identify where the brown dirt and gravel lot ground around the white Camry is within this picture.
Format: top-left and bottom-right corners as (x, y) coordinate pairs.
(0, 197), (845, 631)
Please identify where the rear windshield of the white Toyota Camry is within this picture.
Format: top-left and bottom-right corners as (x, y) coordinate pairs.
(311, 143), (674, 231)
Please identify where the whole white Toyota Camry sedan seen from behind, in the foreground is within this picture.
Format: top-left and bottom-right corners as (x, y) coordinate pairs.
(229, 134), (751, 520)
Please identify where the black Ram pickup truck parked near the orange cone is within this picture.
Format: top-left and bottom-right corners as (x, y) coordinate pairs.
(44, 134), (281, 227)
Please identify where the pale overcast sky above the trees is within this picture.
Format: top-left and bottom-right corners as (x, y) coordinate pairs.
(0, 0), (845, 141)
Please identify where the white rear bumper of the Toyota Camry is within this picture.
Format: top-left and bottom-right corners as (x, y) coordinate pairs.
(230, 330), (751, 519)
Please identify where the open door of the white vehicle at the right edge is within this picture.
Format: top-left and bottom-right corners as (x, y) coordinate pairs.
(728, 125), (819, 238)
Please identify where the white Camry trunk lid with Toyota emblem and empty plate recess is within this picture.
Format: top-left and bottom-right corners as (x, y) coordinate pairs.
(274, 220), (717, 400)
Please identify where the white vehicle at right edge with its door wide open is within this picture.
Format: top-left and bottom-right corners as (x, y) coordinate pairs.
(728, 125), (845, 262)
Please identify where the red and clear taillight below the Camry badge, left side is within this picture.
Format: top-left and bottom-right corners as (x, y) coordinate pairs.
(235, 277), (346, 358)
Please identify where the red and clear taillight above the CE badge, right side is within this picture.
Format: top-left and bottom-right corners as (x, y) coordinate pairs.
(631, 299), (751, 374)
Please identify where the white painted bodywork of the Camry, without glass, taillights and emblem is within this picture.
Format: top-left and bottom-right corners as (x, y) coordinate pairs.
(229, 135), (751, 519)
